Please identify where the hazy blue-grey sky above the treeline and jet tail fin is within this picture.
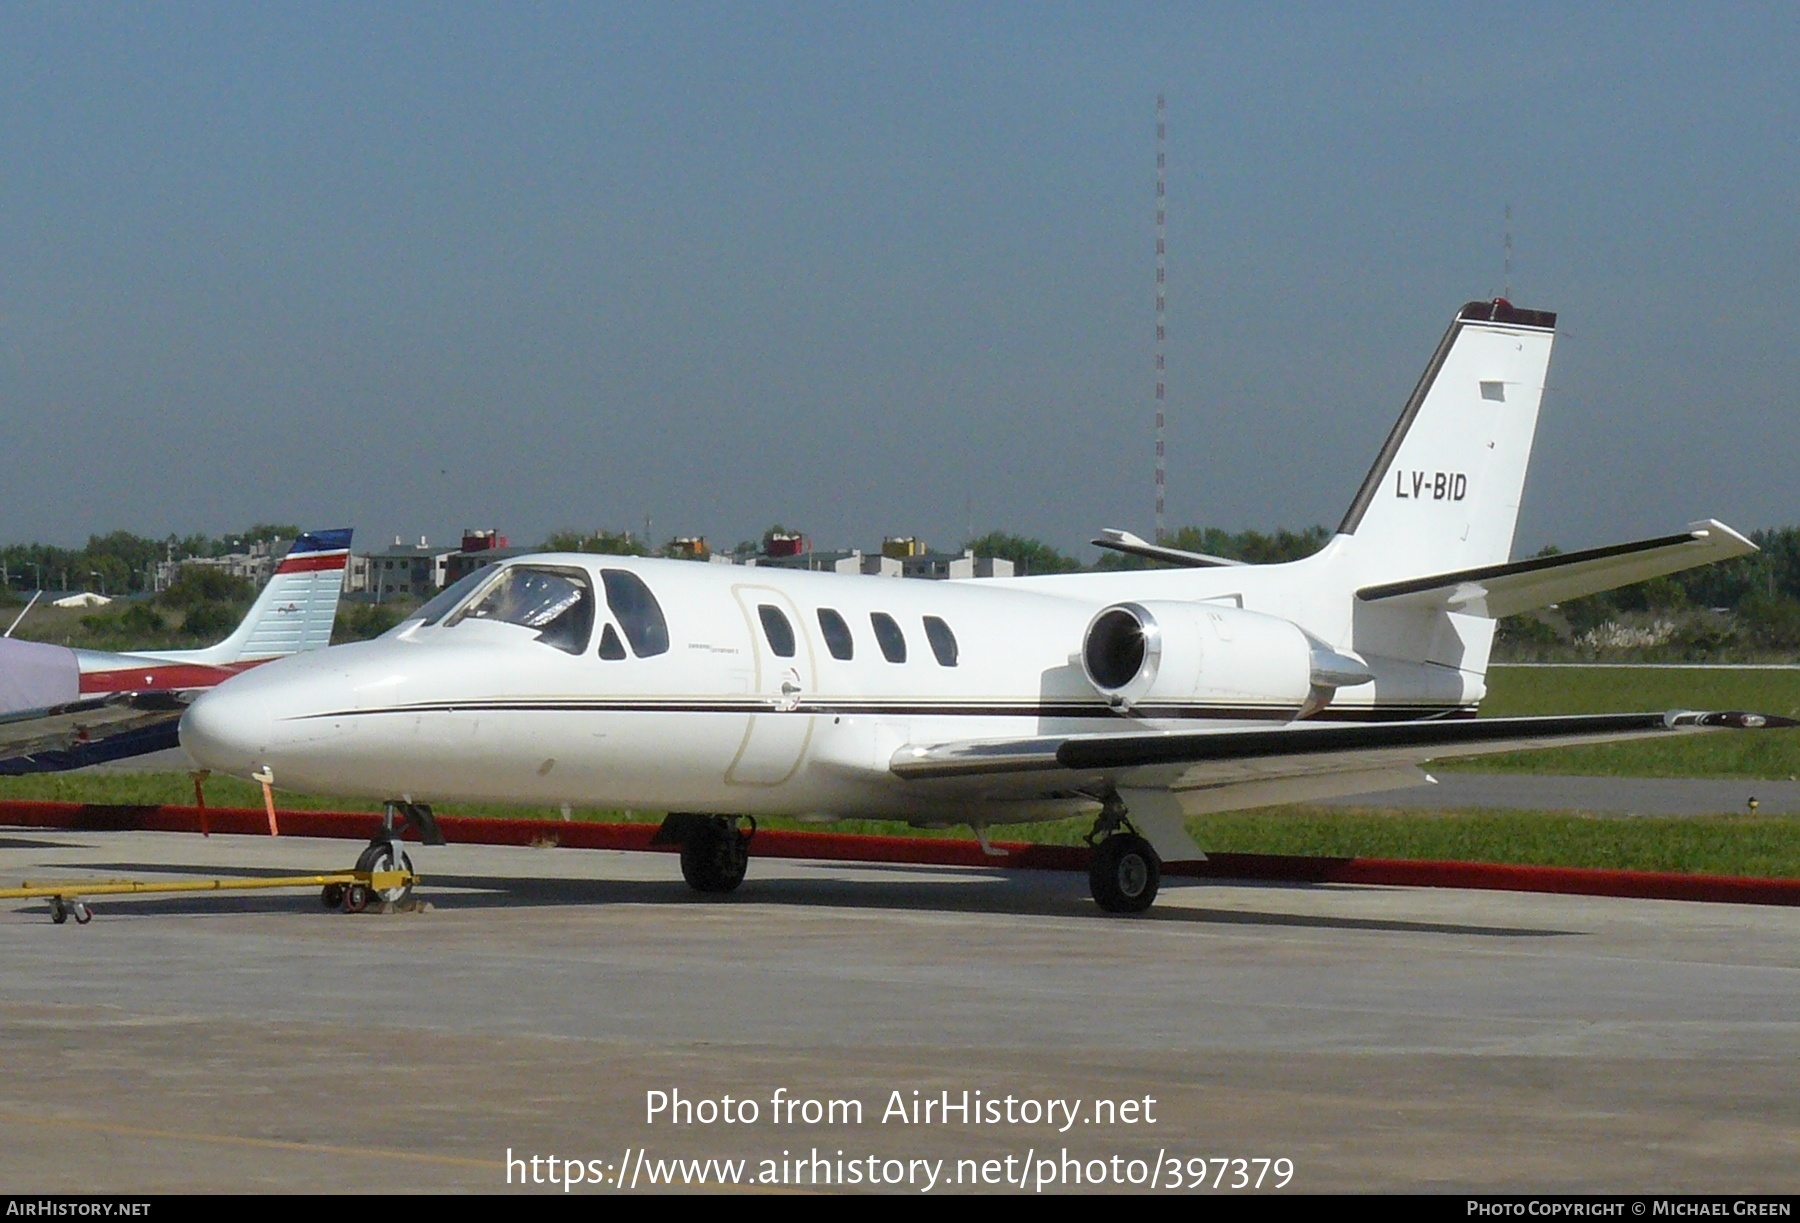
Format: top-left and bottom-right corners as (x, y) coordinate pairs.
(0, 4), (1800, 551)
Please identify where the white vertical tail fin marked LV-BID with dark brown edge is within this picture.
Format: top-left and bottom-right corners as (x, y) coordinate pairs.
(1337, 299), (1557, 582)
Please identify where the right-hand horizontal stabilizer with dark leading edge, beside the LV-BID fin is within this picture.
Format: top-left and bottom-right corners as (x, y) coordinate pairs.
(1357, 521), (1757, 620)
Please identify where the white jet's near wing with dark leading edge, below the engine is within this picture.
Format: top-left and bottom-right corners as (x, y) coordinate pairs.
(889, 711), (1800, 814)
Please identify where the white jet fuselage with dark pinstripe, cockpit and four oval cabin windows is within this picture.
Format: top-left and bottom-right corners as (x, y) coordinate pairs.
(182, 555), (1480, 821)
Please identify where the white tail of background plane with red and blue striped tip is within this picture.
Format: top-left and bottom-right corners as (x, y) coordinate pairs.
(149, 528), (351, 666)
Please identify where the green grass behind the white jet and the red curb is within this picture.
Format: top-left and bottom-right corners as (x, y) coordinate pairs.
(0, 666), (1800, 877)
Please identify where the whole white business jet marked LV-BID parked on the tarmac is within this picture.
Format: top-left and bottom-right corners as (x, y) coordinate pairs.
(180, 301), (1795, 911)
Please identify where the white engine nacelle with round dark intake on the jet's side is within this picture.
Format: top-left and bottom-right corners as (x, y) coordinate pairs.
(1082, 602), (1372, 717)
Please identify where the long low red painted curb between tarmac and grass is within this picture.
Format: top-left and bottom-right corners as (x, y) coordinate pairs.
(0, 802), (1800, 904)
